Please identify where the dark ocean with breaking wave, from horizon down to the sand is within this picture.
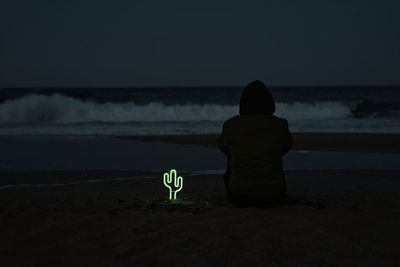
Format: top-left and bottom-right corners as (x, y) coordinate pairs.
(0, 86), (400, 136)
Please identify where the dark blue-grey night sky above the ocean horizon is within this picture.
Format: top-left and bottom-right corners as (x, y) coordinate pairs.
(0, 0), (400, 87)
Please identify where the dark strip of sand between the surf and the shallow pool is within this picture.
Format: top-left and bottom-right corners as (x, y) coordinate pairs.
(0, 132), (400, 153)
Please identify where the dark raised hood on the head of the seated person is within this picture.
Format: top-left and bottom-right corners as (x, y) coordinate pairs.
(239, 80), (275, 115)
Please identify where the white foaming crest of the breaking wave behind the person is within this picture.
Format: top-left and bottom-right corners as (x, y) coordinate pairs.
(0, 94), (351, 123)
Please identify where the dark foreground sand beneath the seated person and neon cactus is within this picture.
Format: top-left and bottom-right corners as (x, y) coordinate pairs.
(0, 170), (400, 266)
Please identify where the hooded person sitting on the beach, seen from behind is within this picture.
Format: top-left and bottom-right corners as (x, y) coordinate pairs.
(217, 80), (292, 207)
